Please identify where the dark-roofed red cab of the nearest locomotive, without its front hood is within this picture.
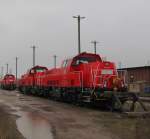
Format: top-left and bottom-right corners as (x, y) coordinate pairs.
(71, 52), (102, 89)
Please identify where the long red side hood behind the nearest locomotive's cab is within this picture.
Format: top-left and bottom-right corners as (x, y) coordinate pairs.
(45, 60), (81, 88)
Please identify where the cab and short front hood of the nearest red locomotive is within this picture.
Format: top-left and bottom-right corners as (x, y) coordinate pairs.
(70, 52), (123, 90)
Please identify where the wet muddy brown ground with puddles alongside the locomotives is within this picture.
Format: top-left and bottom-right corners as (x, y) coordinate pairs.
(0, 90), (150, 139)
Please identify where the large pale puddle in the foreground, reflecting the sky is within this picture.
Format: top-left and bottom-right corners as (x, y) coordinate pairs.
(16, 112), (53, 139)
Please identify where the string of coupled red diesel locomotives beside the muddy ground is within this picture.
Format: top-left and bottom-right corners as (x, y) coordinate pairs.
(18, 52), (132, 111)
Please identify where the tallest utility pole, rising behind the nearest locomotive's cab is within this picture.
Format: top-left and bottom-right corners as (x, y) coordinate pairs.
(73, 15), (85, 54)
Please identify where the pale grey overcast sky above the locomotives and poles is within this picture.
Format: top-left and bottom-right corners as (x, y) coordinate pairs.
(0, 0), (150, 76)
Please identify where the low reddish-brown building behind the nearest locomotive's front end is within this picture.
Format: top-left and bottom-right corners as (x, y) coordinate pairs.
(118, 66), (150, 92)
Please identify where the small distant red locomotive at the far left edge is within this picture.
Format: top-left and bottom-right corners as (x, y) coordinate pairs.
(1, 74), (16, 90)
